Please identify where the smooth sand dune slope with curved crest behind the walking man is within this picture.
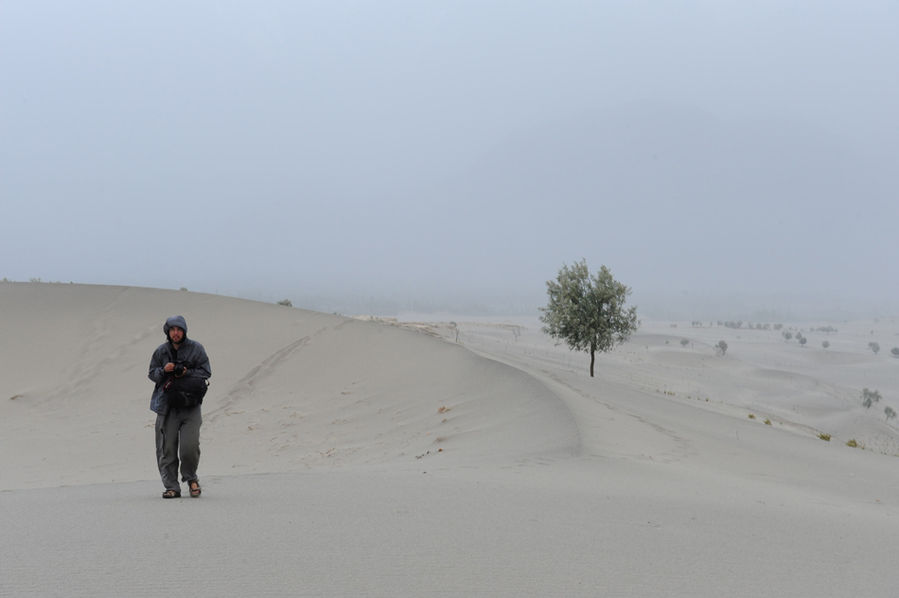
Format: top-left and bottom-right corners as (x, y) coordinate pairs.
(0, 283), (577, 488)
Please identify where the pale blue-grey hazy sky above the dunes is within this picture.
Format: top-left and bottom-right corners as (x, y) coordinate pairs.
(0, 0), (899, 317)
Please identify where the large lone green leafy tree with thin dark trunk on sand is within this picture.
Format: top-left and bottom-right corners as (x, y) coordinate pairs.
(540, 260), (639, 378)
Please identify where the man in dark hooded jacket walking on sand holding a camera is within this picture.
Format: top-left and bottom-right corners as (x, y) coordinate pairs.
(149, 316), (212, 498)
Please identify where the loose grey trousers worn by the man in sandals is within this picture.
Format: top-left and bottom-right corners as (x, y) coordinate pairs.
(156, 405), (203, 492)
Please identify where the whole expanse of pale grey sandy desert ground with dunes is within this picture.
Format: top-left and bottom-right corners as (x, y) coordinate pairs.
(0, 283), (899, 597)
